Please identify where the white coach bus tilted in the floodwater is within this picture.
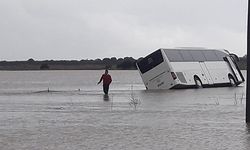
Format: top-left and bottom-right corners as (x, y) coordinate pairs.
(136, 48), (245, 89)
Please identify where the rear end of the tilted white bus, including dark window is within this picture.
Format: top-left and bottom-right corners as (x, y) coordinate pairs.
(136, 49), (177, 89)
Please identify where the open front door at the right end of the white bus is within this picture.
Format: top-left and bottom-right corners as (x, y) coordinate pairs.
(226, 56), (244, 82)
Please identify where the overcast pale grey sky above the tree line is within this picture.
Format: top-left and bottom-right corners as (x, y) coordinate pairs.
(0, 0), (247, 60)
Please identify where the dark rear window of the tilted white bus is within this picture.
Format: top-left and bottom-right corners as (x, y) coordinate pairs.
(137, 50), (163, 73)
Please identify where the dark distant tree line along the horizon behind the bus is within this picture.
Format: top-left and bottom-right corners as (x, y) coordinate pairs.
(0, 55), (247, 70)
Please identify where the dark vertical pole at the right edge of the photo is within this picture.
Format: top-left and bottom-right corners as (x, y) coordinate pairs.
(246, 0), (250, 123)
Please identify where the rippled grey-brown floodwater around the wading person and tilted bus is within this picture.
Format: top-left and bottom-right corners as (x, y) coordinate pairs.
(0, 71), (250, 150)
